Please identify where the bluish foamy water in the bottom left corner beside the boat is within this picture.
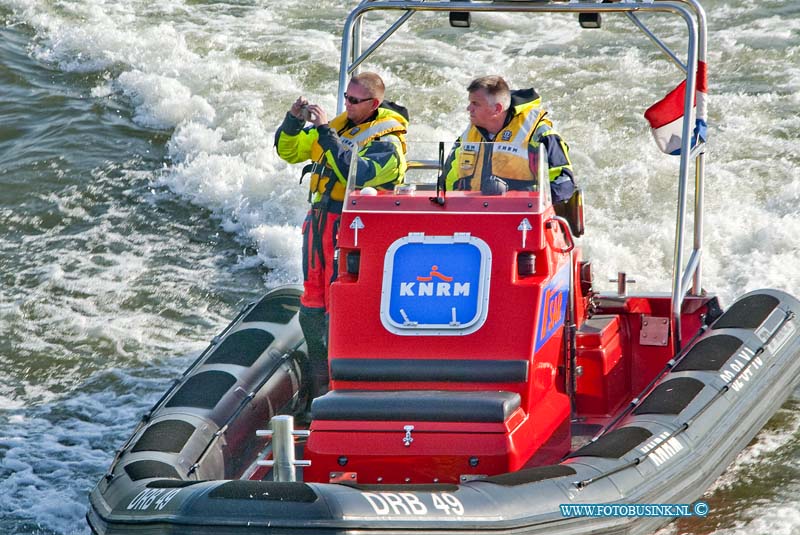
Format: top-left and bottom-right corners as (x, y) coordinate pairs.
(0, 368), (186, 534)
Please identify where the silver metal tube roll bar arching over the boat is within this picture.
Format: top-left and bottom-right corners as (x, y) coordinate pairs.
(337, 0), (707, 351)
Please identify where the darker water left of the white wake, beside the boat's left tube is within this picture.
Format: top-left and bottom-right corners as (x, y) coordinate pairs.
(0, 18), (263, 534)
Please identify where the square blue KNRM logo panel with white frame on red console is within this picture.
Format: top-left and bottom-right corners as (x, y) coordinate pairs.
(381, 237), (489, 334)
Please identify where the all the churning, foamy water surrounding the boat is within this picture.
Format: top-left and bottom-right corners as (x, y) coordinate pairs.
(0, 0), (800, 535)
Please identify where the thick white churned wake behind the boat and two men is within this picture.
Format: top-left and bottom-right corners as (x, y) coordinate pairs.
(6, 0), (800, 302)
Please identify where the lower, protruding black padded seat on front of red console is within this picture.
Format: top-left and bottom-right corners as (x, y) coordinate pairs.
(311, 390), (520, 422)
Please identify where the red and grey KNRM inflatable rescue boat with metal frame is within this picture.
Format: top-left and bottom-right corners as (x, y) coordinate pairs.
(87, 0), (800, 535)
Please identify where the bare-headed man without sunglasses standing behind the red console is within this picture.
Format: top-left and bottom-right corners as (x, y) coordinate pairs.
(445, 76), (575, 204)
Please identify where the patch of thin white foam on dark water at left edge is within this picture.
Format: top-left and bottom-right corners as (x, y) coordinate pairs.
(0, 176), (230, 390)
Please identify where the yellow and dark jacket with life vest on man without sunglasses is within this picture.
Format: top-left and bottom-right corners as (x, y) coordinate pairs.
(444, 89), (575, 203)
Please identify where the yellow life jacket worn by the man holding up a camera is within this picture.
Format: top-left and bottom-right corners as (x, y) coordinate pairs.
(309, 108), (408, 203)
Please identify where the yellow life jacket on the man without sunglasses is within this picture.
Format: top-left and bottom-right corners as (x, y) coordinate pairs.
(456, 99), (552, 190)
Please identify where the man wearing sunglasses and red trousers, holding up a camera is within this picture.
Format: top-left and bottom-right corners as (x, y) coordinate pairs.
(275, 72), (408, 397)
